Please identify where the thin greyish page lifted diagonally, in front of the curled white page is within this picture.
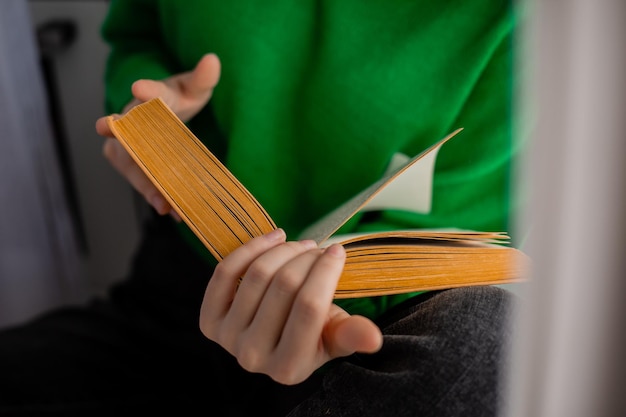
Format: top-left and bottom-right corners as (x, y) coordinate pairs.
(299, 128), (463, 244)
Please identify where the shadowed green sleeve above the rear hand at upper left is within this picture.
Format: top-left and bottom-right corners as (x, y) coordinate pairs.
(101, 0), (176, 113)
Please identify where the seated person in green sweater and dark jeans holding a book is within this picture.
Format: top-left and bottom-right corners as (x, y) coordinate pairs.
(0, 0), (518, 417)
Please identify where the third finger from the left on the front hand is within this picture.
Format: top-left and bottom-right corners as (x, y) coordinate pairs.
(241, 245), (322, 353)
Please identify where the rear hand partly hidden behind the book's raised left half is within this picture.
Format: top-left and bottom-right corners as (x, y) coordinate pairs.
(96, 54), (221, 219)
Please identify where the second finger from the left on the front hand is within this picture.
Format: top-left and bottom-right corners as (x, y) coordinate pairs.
(224, 240), (317, 342)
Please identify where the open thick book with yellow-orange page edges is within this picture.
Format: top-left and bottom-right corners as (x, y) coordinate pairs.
(108, 98), (528, 298)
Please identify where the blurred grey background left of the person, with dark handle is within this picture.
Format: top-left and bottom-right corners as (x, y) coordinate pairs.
(0, 0), (141, 327)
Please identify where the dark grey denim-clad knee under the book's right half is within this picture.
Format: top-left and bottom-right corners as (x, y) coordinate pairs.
(289, 287), (512, 417)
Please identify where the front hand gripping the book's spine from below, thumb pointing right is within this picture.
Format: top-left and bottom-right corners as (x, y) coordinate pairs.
(200, 229), (382, 384)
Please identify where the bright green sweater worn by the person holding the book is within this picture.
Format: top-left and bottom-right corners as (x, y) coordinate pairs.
(102, 0), (516, 317)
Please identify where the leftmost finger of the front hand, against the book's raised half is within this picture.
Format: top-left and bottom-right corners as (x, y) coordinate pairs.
(200, 229), (286, 334)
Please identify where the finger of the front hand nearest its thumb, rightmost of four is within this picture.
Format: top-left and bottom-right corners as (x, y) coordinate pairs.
(276, 245), (346, 367)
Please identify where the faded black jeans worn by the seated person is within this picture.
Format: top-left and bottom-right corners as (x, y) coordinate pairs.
(0, 213), (511, 417)
